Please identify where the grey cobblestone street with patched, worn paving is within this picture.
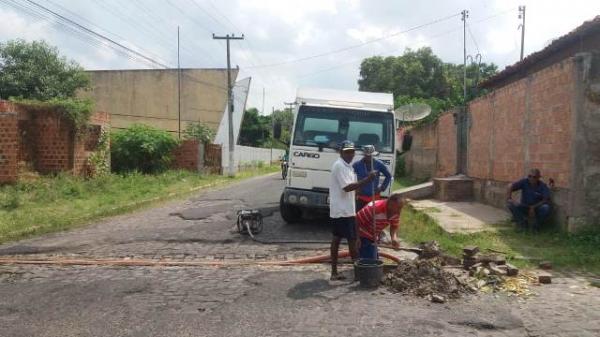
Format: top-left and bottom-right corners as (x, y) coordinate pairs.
(0, 175), (600, 337)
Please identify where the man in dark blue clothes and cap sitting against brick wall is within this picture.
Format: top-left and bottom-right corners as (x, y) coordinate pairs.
(506, 169), (551, 230)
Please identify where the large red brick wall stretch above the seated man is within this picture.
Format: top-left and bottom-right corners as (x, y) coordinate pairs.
(468, 60), (573, 187)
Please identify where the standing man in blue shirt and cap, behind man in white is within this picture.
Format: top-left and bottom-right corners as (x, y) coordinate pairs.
(352, 145), (392, 212)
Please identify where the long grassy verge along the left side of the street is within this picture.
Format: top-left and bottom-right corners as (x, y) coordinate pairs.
(0, 166), (279, 243)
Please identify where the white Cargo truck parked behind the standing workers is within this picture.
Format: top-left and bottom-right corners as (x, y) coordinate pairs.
(280, 88), (397, 223)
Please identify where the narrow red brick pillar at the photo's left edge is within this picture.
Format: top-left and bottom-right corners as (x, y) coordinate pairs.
(0, 111), (18, 183)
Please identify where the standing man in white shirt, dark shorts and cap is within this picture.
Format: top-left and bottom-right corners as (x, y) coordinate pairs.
(329, 140), (377, 280)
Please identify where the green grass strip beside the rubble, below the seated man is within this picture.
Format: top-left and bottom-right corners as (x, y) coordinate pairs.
(399, 207), (600, 274)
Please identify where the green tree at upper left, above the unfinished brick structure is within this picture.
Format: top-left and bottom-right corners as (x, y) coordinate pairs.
(0, 40), (90, 101)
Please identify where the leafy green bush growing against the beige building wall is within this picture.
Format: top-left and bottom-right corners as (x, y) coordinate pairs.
(110, 124), (179, 173)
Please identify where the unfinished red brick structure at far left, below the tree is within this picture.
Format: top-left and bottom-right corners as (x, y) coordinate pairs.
(0, 101), (110, 183)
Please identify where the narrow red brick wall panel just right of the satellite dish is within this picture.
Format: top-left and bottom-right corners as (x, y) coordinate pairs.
(436, 113), (456, 177)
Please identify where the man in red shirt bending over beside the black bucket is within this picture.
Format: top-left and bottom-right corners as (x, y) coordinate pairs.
(356, 194), (404, 259)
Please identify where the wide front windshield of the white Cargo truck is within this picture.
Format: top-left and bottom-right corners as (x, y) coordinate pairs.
(294, 105), (394, 153)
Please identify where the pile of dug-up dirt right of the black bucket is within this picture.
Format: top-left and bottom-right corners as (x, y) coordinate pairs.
(383, 259), (472, 301)
